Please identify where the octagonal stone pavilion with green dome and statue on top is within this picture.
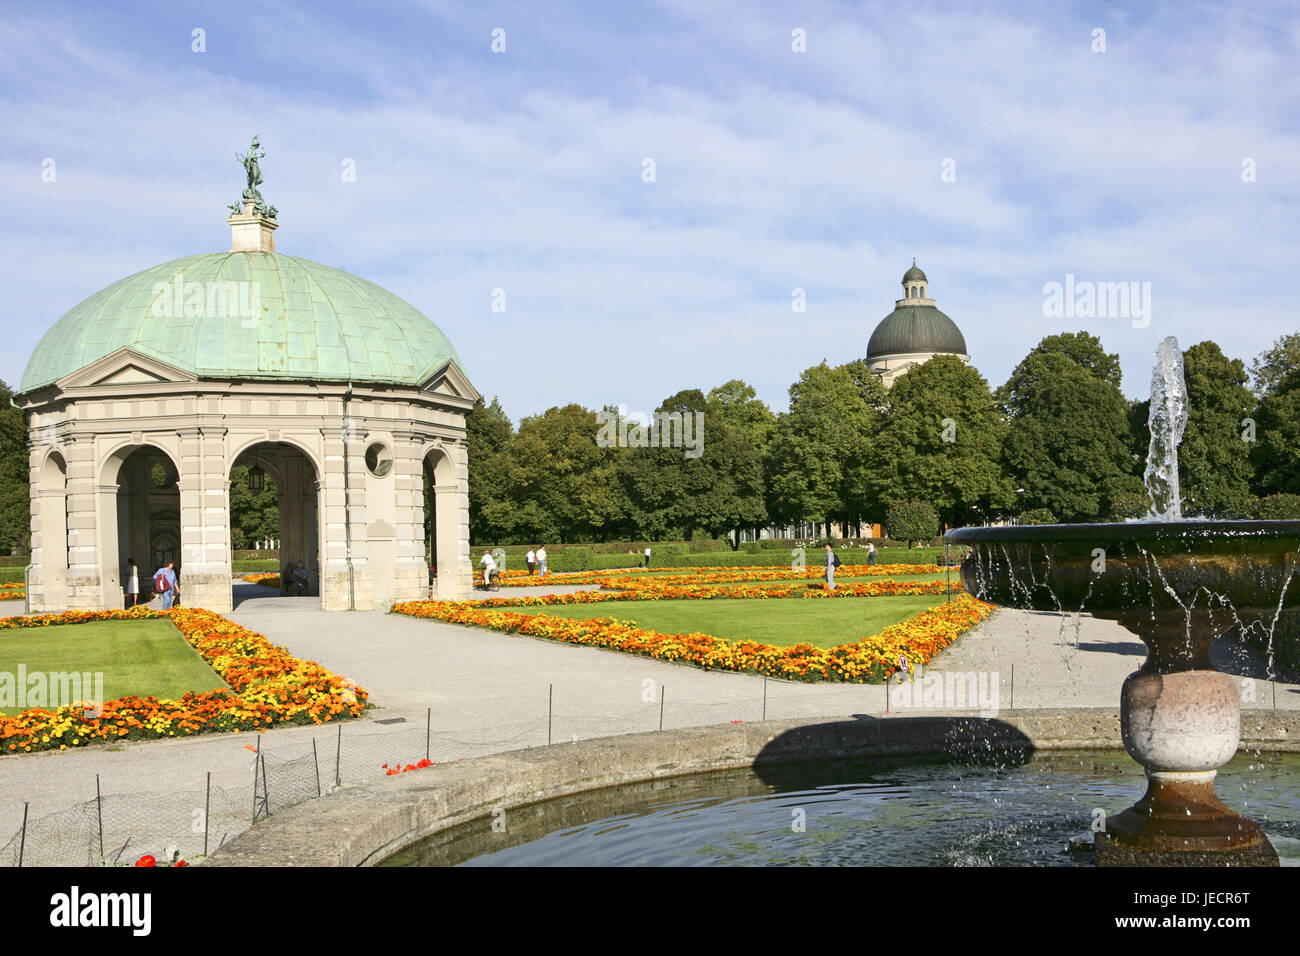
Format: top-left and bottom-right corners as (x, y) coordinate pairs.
(16, 139), (478, 611)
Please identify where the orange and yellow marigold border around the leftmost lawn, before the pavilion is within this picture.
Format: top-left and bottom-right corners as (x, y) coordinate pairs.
(0, 607), (368, 753)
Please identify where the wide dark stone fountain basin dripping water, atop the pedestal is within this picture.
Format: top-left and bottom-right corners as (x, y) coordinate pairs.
(944, 520), (1300, 616)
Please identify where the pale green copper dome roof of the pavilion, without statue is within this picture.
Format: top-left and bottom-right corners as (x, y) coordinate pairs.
(20, 251), (464, 392)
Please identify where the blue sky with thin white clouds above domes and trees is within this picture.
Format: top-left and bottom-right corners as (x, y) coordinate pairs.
(0, 0), (1300, 421)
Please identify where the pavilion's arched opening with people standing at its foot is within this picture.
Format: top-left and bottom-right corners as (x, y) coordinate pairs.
(99, 445), (185, 607)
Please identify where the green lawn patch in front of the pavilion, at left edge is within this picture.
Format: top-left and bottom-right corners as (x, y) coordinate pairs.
(0, 620), (226, 714)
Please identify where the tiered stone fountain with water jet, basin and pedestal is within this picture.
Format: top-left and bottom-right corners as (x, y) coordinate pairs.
(945, 337), (1300, 866)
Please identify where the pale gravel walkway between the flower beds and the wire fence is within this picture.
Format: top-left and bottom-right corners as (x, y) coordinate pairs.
(0, 585), (1300, 863)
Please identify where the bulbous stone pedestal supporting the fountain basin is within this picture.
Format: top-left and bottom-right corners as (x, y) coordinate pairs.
(1097, 611), (1278, 866)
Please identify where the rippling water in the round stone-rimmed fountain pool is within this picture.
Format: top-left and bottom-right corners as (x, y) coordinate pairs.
(384, 752), (1300, 866)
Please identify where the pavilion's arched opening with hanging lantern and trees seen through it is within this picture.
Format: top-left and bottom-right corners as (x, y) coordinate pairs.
(228, 441), (321, 598)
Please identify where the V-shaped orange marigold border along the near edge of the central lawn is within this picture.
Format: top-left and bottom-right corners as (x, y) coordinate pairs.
(393, 592), (993, 683)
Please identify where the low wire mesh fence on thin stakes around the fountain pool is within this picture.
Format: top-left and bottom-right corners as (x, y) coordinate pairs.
(0, 663), (1300, 866)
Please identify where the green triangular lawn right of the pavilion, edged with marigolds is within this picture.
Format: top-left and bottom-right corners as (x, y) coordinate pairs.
(533, 594), (944, 648)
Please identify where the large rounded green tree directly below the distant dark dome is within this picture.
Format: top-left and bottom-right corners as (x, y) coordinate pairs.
(863, 355), (1015, 525)
